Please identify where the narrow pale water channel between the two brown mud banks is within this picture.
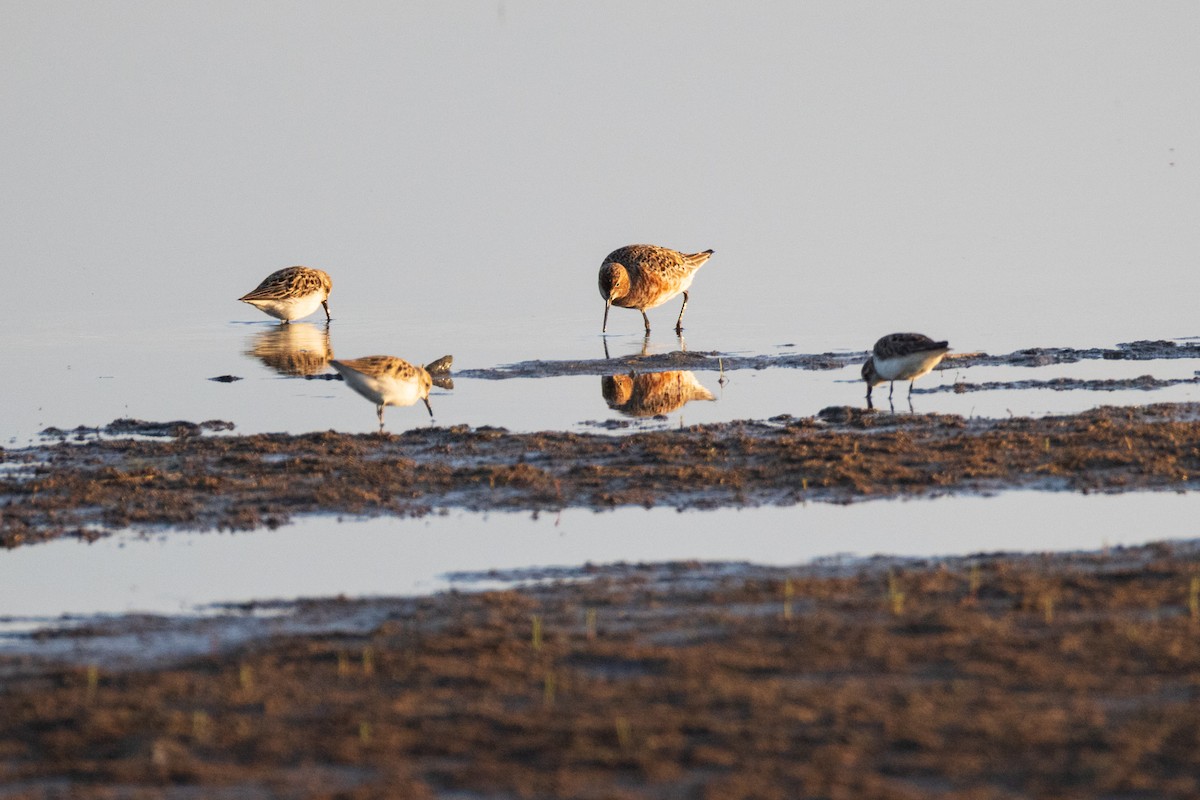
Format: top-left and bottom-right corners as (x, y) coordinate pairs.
(0, 492), (1200, 632)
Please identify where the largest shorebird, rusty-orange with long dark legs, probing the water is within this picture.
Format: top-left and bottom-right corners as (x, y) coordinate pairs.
(600, 245), (713, 333)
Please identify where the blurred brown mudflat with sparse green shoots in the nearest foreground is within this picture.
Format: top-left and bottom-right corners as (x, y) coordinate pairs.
(0, 543), (1200, 800)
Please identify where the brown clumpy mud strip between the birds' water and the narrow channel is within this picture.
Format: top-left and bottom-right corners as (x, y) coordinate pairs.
(0, 404), (1200, 547)
